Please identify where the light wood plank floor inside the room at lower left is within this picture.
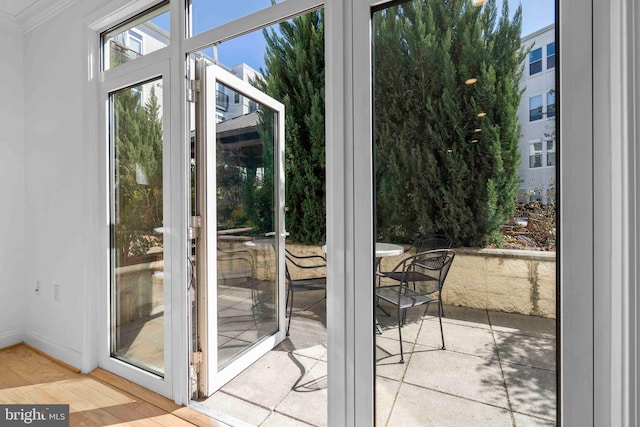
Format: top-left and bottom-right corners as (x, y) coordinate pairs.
(0, 344), (219, 426)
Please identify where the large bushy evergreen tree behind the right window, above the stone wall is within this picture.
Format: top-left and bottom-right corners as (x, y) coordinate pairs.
(374, 0), (525, 246)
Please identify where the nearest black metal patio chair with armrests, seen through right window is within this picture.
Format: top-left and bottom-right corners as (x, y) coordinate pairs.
(376, 249), (456, 363)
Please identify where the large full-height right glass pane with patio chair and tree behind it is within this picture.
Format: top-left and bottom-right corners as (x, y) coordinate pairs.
(370, 0), (557, 426)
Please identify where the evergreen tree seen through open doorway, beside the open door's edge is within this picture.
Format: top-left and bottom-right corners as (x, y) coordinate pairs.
(254, 11), (326, 244)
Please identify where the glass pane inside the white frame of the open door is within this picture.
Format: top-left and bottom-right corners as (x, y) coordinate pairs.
(216, 82), (278, 369)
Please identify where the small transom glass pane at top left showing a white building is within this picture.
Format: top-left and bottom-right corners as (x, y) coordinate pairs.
(102, 2), (170, 70)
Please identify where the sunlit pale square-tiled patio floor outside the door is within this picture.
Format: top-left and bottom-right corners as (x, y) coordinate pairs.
(199, 292), (556, 427)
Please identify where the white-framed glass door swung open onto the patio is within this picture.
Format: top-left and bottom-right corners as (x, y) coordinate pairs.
(195, 59), (286, 397)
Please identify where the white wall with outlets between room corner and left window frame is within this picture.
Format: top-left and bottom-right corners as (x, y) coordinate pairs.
(23, 1), (99, 367)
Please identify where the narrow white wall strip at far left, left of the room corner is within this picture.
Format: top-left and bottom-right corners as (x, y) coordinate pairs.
(0, 22), (28, 348)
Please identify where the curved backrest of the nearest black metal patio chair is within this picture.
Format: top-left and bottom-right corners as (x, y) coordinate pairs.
(402, 249), (456, 294)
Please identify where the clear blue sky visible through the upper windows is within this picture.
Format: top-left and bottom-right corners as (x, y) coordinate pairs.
(153, 0), (555, 70)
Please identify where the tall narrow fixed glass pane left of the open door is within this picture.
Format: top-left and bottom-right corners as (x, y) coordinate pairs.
(110, 79), (164, 375)
